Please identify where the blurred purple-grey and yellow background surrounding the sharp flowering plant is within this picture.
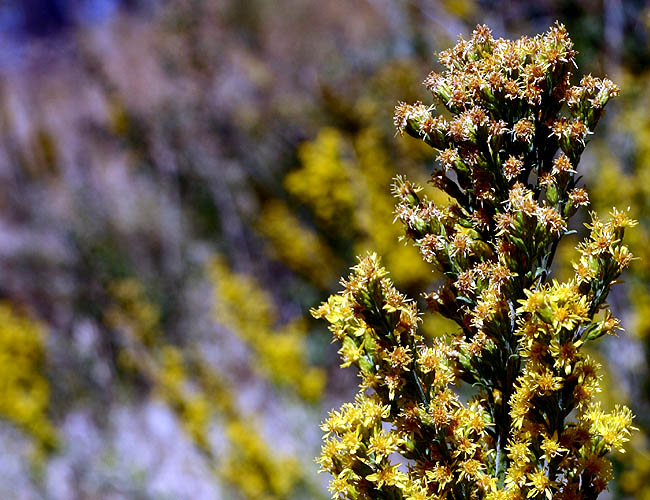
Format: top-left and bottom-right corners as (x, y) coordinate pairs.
(0, 0), (650, 500)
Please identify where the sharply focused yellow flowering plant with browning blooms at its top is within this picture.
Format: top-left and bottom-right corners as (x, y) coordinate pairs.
(312, 24), (635, 500)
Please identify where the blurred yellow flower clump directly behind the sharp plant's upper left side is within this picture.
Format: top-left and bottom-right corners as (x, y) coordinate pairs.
(280, 125), (426, 288)
